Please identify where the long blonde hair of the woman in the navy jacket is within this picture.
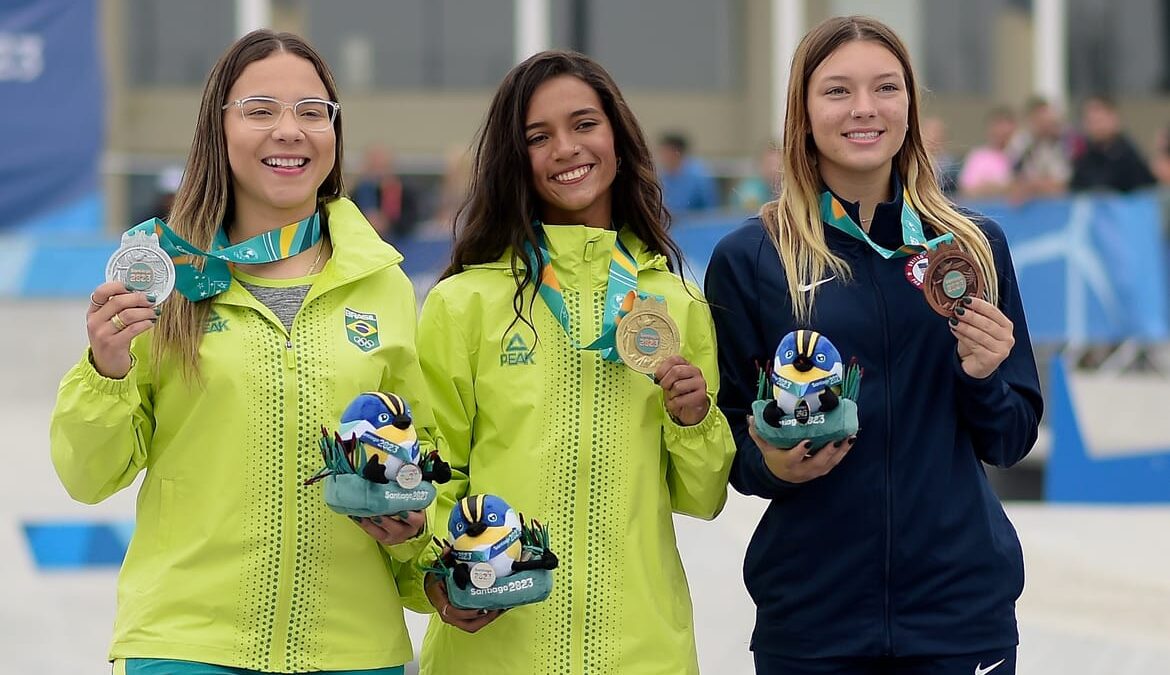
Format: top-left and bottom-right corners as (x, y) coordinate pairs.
(761, 16), (999, 323)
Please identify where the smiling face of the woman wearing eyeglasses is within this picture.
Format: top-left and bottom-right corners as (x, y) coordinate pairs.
(223, 51), (337, 227)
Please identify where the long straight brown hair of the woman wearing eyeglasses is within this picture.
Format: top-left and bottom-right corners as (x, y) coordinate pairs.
(152, 30), (345, 379)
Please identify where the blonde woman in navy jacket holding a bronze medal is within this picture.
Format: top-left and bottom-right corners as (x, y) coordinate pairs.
(707, 16), (1042, 675)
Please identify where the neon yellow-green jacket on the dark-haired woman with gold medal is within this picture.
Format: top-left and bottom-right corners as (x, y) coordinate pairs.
(419, 226), (735, 675)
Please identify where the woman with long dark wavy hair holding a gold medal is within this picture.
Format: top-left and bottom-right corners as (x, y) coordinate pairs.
(419, 51), (735, 675)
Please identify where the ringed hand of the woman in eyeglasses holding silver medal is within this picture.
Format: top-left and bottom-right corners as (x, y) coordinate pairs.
(85, 281), (159, 380)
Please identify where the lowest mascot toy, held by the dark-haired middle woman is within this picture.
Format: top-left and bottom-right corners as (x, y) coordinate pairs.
(426, 495), (557, 609)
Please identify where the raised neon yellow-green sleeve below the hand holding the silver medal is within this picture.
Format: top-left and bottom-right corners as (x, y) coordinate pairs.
(49, 340), (154, 504)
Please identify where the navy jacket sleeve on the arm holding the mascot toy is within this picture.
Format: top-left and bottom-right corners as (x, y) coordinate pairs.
(704, 229), (797, 500)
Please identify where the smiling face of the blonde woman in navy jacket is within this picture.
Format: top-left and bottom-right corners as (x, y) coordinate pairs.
(806, 40), (910, 187)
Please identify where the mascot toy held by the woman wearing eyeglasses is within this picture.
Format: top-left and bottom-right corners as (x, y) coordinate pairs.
(305, 392), (450, 517)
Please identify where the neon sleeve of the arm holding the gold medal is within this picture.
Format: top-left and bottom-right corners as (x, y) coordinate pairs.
(659, 281), (735, 519)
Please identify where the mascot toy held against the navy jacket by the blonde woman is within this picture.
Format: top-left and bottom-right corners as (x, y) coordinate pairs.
(751, 330), (861, 454)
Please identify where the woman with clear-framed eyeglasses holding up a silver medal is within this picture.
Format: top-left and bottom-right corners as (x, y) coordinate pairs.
(50, 30), (433, 675)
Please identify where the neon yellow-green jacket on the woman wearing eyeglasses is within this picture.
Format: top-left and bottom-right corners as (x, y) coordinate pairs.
(50, 200), (434, 673)
